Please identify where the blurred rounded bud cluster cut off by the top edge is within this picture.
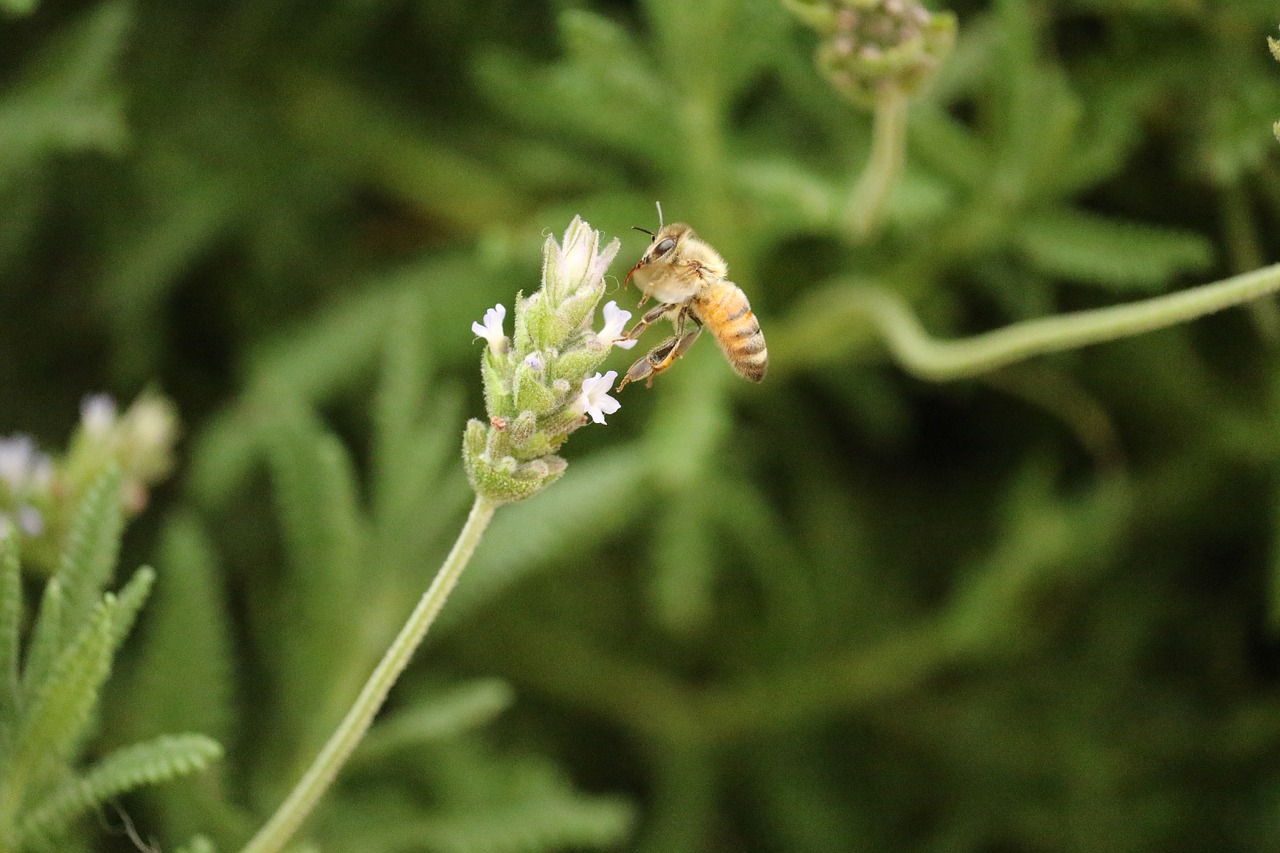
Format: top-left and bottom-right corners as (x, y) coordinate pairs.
(786, 0), (956, 108)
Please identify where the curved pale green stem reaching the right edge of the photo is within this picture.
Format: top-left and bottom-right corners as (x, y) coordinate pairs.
(845, 258), (1280, 382)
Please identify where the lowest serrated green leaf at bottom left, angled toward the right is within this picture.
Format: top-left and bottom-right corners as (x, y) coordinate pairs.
(19, 734), (223, 839)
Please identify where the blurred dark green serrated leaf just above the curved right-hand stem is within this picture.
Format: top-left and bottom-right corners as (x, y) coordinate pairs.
(1012, 210), (1213, 292)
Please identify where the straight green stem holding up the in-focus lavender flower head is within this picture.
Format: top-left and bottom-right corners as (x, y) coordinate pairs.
(242, 496), (498, 853)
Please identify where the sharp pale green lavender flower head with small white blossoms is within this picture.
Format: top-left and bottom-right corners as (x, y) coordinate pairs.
(462, 216), (630, 502)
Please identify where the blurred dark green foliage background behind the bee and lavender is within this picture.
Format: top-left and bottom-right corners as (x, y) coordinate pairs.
(0, 0), (1280, 853)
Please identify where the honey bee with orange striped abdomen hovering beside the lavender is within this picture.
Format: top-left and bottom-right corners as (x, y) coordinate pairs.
(618, 207), (769, 391)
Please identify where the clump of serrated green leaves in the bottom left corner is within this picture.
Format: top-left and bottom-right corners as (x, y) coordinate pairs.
(0, 473), (221, 850)
